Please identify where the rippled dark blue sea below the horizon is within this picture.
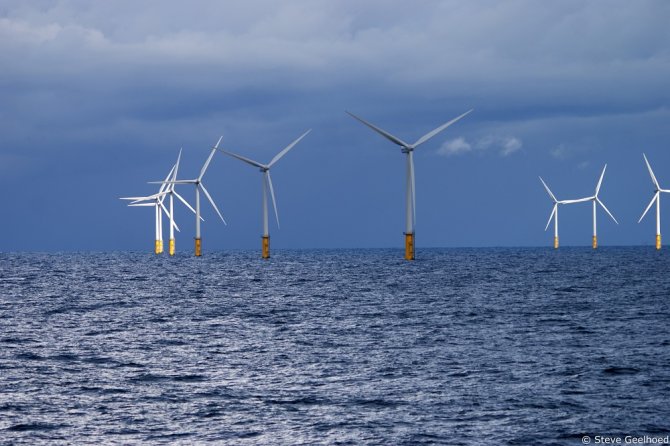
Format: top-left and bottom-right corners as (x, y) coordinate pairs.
(0, 247), (670, 445)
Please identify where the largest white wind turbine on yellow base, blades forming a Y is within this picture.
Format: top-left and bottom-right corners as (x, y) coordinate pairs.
(347, 110), (472, 260)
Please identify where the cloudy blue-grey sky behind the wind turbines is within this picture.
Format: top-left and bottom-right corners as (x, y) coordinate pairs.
(0, 0), (670, 252)
